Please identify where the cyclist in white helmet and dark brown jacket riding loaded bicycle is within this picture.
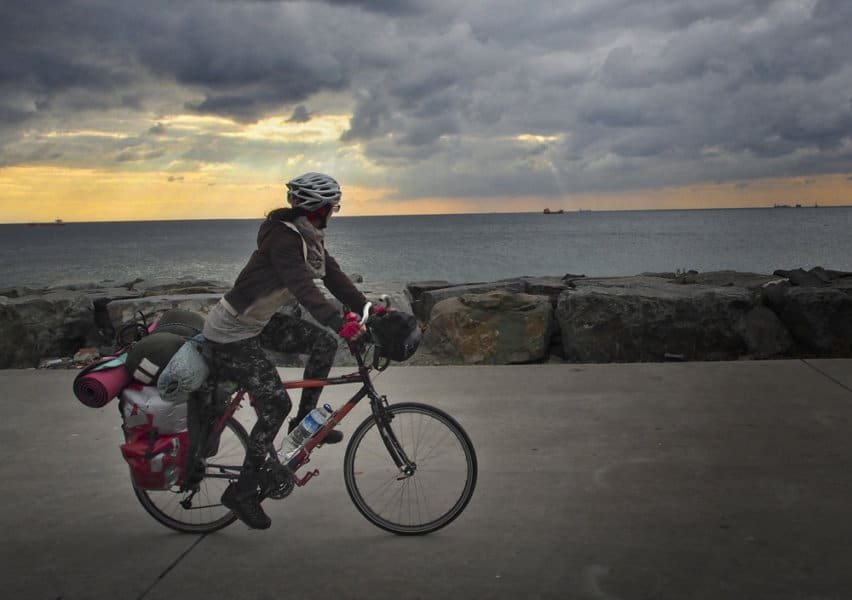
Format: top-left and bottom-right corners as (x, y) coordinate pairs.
(203, 173), (367, 529)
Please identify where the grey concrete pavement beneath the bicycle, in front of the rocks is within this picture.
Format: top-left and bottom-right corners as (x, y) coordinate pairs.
(0, 360), (852, 600)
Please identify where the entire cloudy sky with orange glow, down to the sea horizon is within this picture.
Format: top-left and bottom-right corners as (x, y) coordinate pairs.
(0, 0), (852, 221)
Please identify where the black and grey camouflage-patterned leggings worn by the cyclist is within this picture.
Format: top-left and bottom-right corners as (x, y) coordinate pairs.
(208, 314), (337, 471)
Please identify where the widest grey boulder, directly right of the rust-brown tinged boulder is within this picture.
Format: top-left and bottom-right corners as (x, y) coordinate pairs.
(556, 276), (790, 362)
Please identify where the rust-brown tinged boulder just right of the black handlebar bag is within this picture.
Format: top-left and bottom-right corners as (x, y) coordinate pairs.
(424, 290), (554, 365)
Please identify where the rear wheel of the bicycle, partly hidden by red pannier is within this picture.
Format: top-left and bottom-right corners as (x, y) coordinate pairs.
(133, 419), (248, 533)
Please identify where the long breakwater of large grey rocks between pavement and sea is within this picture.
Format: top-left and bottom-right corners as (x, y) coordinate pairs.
(0, 267), (852, 368)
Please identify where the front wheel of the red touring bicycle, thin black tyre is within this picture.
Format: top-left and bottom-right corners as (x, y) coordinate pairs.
(343, 402), (477, 535)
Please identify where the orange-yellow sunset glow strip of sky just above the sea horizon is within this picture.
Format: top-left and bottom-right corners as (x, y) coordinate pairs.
(0, 166), (852, 223)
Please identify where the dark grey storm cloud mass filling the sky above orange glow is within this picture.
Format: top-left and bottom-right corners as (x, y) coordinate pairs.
(5, 0), (852, 202)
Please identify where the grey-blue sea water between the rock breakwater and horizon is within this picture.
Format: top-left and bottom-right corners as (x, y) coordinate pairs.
(0, 207), (852, 286)
